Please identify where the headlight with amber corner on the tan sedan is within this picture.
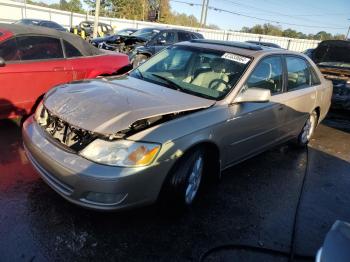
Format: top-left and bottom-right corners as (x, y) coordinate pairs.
(80, 139), (160, 167)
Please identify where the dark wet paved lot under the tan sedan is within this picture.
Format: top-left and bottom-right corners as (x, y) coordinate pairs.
(0, 111), (350, 261)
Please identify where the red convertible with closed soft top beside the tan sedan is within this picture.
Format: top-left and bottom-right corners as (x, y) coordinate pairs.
(0, 23), (129, 119)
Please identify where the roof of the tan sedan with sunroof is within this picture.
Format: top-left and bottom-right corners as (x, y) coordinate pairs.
(176, 39), (296, 57)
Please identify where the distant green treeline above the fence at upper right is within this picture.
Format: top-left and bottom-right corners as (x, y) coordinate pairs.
(241, 24), (345, 40)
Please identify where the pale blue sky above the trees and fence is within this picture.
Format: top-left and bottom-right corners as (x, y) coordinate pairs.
(169, 0), (350, 34)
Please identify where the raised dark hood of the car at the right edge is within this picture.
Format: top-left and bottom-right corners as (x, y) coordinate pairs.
(312, 40), (350, 64)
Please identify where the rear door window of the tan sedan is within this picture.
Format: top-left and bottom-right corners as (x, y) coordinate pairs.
(286, 56), (312, 91)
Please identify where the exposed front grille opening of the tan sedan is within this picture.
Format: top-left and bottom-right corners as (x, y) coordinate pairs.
(39, 108), (96, 152)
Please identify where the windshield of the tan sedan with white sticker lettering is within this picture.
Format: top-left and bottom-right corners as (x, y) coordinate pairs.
(130, 46), (251, 100)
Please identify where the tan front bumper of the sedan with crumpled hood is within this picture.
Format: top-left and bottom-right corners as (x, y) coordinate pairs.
(22, 117), (171, 210)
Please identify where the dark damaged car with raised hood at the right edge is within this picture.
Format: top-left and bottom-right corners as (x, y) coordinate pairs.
(311, 40), (350, 110)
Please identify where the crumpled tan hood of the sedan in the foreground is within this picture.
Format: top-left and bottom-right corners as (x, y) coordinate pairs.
(44, 77), (215, 135)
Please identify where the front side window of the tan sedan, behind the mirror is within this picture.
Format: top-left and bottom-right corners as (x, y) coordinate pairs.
(245, 56), (283, 95)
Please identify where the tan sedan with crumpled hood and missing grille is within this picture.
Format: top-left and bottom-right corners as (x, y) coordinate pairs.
(23, 40), (332, 210)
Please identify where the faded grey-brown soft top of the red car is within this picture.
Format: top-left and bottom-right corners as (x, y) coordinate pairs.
(0, 23), (102, 56)
